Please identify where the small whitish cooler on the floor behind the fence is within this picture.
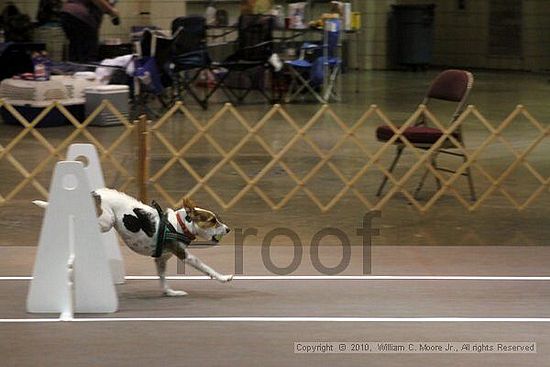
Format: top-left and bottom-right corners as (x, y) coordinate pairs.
(85, 84), (130, 126)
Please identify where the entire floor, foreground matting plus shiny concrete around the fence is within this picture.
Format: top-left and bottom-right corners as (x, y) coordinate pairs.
(0, 71), (550, 366)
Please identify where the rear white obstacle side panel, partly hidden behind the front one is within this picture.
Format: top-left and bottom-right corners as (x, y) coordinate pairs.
(67, 144), (126, 284)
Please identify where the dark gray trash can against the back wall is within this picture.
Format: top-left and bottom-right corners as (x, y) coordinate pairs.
(392, 4), (435, 68)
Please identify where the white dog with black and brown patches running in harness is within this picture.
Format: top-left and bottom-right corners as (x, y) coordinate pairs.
(33, 189), (233, 296)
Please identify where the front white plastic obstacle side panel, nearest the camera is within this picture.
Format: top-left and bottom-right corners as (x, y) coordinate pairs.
(27, 161), (118, 320)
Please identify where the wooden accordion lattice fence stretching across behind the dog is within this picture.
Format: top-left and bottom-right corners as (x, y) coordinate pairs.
(0, 101), (550, 212)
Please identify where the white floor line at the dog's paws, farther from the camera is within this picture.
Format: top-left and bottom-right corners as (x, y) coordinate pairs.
(0, 275), (550, 281)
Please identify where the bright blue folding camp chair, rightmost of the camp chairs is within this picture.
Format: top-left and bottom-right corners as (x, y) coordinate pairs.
(285, 19), (342, 103)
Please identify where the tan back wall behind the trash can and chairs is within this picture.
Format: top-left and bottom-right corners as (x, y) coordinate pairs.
(4, 0), (550, 70)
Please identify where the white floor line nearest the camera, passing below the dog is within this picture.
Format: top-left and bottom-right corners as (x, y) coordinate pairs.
(0, 316), (550, 323)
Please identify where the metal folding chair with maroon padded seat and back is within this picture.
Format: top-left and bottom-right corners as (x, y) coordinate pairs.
(376, 69), (476, 201)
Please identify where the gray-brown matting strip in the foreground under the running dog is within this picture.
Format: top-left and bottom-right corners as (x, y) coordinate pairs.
(0, 246), (550, 366)
